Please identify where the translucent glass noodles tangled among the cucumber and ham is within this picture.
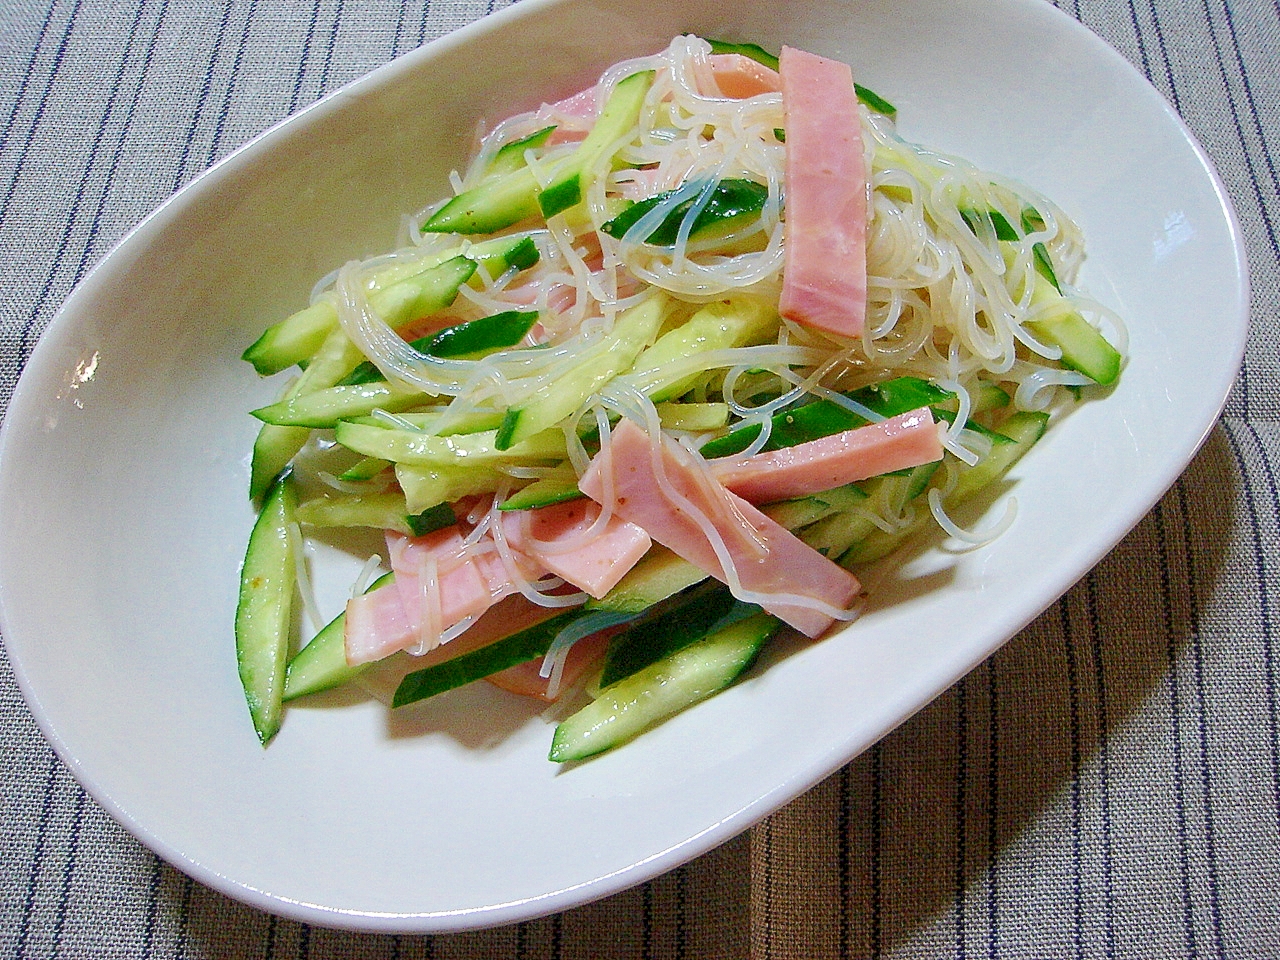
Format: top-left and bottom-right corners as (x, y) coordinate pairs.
(315, 37), (1126, 634)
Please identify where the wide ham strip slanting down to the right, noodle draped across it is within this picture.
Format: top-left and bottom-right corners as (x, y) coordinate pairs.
(579, 420), (861, 636)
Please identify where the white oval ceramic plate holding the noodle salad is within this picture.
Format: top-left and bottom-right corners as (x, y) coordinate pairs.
(0, 0), (1247, 932)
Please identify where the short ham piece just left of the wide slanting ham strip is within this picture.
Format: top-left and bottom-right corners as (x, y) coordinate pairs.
(503, 500), (653, 599)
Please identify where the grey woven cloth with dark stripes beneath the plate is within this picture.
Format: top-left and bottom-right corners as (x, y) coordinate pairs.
(0, 0), (1280, 960)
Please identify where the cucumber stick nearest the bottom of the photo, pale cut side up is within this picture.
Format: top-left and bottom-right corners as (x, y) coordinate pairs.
(549, 613), (782, 763)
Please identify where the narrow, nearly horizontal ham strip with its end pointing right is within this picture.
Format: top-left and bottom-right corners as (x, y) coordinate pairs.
(712, 407), (942, 503)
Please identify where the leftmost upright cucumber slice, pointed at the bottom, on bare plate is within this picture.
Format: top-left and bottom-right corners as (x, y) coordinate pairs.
(236, 474), (297, 746)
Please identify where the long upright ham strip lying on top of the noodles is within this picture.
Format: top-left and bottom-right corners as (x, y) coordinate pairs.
(778, 47), (867, 337)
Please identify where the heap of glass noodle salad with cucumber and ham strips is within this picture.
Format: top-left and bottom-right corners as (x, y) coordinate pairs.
(236, 36), (1126, 762)
